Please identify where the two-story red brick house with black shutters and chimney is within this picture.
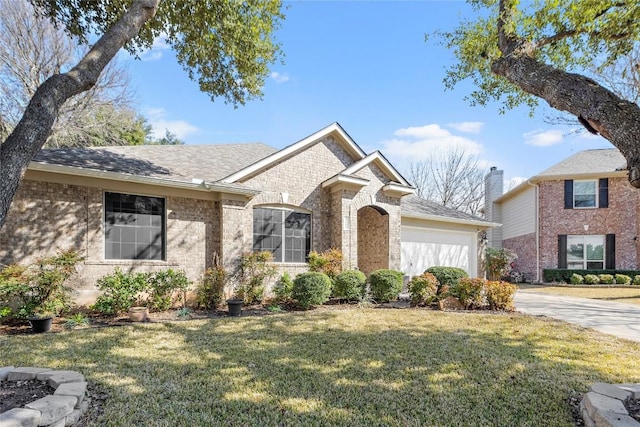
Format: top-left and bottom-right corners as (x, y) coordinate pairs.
(485, 149), (640, 281)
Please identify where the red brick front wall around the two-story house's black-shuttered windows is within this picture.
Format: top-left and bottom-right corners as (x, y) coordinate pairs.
(539, 177), (640, 269)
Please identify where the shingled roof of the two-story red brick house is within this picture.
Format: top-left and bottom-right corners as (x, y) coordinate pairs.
(535, 148), (627, 178)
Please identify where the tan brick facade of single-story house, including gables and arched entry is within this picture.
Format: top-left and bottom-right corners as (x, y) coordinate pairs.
(0, 136), (401, 303)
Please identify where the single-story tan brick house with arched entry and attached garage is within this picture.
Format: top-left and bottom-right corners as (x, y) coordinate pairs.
(0, 123), (492, 302)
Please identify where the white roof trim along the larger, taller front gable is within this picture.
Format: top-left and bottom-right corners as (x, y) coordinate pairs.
(221, 122), (365, 183)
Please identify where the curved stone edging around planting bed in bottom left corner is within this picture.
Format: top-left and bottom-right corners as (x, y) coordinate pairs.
(0, 366), (89, 427)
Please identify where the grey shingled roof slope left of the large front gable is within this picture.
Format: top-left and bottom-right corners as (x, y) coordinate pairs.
(34, 143), (278, 182)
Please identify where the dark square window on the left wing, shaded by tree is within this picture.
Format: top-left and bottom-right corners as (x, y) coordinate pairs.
(104, 192), (165, 260)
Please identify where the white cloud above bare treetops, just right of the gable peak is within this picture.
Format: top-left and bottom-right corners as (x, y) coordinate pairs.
(382, 124), (482, 160)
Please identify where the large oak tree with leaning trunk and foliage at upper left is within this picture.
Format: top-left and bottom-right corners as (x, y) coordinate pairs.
(0, 0), (283, 227)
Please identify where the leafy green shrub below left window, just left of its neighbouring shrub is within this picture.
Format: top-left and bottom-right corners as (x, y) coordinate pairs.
(91, 267), (148, 315)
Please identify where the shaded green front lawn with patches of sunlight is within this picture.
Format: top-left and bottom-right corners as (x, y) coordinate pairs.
(0, 308), (640, 426)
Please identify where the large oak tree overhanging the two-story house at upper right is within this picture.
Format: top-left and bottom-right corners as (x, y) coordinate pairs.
(439, 0), (640, 188)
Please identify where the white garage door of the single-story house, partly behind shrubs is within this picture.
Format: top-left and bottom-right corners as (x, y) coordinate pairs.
(400, 226), (476, 277)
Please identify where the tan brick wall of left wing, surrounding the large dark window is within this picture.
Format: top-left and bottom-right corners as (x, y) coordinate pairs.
(0, 180), (220, 304)
